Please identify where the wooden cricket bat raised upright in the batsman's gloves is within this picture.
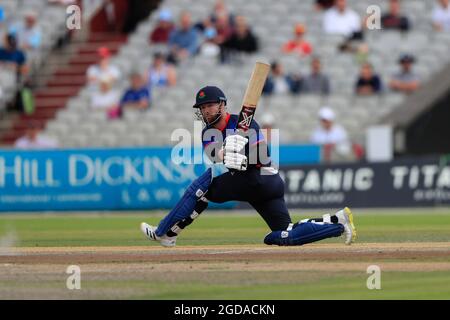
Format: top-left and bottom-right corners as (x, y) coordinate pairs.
(236, 62), (270, 132)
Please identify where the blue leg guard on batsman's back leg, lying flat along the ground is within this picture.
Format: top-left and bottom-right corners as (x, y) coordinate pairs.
(264, 222), (344, 246)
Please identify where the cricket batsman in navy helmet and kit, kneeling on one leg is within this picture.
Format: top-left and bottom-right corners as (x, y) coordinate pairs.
(141, 86), (356, 247)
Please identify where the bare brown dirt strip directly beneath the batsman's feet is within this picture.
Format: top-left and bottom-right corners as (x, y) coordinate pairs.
(0, 242), (450, 264)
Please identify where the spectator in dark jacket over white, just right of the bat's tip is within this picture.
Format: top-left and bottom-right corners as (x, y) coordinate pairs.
(263, 61), (301, 95)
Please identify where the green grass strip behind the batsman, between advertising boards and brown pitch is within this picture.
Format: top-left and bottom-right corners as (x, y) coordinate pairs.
(0, 209), (450, 247)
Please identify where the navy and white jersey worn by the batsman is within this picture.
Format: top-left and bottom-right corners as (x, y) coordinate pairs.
(202, 113), (270, 168)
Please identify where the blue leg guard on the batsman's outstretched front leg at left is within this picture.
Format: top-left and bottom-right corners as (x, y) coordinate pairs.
(155, 168), (212, 237)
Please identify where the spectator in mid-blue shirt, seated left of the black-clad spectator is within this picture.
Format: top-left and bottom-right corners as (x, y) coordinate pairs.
(169, 11), (200, 64)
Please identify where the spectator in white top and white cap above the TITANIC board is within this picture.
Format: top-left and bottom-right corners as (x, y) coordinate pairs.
(311, 107), (352, 161)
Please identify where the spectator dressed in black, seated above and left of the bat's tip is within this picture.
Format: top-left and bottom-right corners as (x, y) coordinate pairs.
(221, 16), (258, 62)
